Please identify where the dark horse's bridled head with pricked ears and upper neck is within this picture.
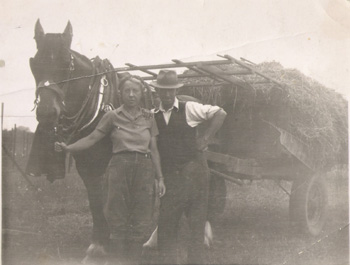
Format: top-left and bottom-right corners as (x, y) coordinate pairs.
(30, 19), (91, 125)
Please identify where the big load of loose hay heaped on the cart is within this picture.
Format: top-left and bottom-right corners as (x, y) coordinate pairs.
(179, 62), (348, 169)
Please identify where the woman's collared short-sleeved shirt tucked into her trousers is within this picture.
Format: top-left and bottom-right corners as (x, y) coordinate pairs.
(96, 105), (158, 153)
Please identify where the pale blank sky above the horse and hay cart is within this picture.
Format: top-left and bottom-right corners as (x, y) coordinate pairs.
(0, 0), (350, 131)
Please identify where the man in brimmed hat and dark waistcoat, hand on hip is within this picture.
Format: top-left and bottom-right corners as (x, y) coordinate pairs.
(151, 70), (226, 264)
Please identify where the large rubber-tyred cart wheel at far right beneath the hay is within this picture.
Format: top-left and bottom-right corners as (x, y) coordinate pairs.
(289, 175), (327, 236)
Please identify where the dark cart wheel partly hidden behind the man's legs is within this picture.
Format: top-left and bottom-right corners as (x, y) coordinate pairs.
(208, 176), (226, 222)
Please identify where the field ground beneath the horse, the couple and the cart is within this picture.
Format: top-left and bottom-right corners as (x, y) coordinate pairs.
(2, 157), (349, 265)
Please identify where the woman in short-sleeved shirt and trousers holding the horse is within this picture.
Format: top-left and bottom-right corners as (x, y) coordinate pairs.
(55, 76), (165, 264)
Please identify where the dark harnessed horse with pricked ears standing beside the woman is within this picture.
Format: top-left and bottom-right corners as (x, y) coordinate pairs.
(27, 20), (134, 256)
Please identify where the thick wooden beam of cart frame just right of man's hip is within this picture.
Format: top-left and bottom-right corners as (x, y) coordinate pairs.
(205, 151), (263, 178)
